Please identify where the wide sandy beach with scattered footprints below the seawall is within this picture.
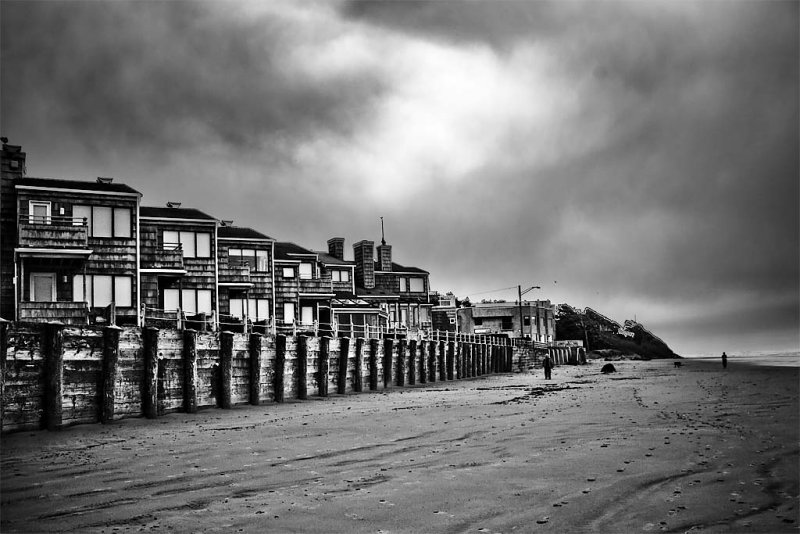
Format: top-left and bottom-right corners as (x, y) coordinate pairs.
(0, 360), (800, 532)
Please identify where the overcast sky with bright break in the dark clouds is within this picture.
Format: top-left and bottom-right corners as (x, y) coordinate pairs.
(0, 0), (800, 360)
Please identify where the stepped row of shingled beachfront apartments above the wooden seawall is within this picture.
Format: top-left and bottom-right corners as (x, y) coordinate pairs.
(0, 143), (432, 336)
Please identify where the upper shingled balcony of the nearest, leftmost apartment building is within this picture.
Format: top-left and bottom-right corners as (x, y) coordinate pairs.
(18, 215), (89, 250)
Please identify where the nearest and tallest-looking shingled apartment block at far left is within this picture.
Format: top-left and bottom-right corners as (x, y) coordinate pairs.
(0, 143), (141, 325)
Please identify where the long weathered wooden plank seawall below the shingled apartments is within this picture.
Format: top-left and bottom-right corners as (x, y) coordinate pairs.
(0, 323), (541, 432)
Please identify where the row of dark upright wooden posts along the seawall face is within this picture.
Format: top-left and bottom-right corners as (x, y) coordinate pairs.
(0, 323), (513, 430)
